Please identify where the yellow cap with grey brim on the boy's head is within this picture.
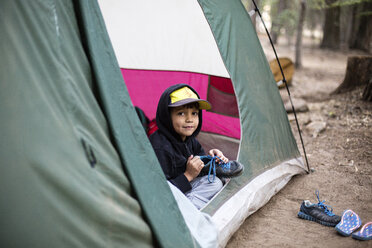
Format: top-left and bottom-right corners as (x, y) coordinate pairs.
(168, 86), (212, 109)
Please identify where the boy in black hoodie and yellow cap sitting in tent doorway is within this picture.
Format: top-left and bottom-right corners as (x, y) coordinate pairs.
(150, 84), (243, 209)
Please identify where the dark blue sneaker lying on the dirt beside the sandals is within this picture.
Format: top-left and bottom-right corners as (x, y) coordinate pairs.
(297, 190), (341, 227)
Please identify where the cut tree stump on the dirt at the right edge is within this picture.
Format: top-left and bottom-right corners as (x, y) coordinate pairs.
(332, 56), (372, 94)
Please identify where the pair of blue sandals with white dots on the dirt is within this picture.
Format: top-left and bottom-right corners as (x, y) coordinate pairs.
(336, 209), (372, 240)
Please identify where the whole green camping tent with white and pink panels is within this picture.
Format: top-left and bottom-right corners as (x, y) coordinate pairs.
(0, 0), (305, 247)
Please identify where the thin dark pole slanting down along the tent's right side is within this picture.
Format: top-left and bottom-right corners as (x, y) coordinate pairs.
(252, 0), (310, 174)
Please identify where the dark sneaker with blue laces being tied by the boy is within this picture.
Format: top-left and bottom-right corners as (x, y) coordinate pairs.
(200, 155), (244, 182)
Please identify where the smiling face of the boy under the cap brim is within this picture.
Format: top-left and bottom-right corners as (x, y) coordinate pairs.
(171, 106), (199, 141)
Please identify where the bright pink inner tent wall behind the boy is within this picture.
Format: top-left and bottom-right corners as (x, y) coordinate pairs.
(121, 69), (240, 139)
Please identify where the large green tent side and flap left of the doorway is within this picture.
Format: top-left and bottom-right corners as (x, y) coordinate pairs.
(0, 0), (198, 247)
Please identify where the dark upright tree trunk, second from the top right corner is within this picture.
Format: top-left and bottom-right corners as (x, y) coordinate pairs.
(320, 0), (340, 49)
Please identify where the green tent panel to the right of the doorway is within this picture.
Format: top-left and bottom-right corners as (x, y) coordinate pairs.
(199, 0), (300, 214)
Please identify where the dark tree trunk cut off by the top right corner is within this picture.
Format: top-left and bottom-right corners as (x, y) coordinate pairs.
(349, 2), (372, 52)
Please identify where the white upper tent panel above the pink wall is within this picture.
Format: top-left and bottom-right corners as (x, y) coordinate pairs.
(99, 0), (230, 77)
